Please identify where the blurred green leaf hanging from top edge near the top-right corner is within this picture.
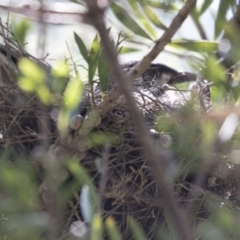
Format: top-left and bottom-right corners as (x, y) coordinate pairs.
(214, 0), (235, 39)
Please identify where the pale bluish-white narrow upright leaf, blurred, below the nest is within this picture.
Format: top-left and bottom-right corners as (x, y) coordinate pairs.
(80, 185), (93, 224)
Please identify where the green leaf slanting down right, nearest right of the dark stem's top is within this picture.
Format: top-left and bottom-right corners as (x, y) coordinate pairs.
(111, 3), (152, 40)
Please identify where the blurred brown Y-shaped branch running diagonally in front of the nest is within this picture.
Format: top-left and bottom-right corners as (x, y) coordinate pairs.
(86, 0), (196, 240)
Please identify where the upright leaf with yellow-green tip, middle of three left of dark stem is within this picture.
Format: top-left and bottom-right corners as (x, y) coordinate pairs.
(88, 35), (100, 84)
